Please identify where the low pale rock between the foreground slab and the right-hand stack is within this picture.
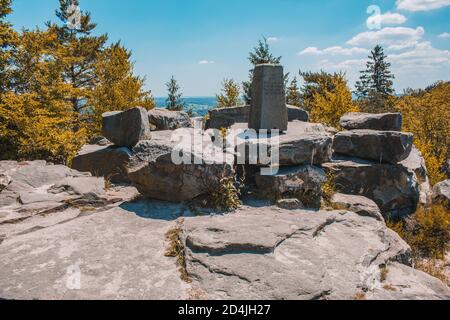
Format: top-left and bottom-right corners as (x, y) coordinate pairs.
(331, 193), (384, 221)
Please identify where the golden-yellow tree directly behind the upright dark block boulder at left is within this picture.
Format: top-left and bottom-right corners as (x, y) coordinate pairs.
(89, 42), (155, 133)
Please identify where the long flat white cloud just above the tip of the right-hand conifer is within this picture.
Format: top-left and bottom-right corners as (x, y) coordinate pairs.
(347, 27), (425, 46)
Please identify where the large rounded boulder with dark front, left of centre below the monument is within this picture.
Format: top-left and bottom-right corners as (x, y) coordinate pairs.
(128, 129), (234, 202)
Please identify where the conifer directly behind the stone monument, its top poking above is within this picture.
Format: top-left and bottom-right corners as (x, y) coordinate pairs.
(242, 37), (281, 104)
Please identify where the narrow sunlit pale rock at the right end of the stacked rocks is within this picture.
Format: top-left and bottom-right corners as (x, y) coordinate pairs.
(400, 146), (433, 205)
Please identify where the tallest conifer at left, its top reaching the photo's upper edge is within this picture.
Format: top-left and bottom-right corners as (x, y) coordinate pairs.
(47, 0), (108, 112)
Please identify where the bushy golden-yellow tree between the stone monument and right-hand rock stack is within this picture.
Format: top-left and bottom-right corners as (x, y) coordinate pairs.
(300, 71), (359, 128)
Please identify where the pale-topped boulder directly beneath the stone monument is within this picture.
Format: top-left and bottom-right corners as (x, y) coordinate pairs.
(232, 121), (333, 167)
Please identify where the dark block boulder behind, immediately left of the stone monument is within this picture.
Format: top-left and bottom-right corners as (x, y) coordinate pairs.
(205, 106), (250, 129)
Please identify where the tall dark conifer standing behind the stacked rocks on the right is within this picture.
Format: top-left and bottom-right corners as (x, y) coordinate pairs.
(355, 45), (395, 112)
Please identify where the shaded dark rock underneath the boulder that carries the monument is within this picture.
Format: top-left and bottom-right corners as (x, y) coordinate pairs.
(255, 165), (327, 208)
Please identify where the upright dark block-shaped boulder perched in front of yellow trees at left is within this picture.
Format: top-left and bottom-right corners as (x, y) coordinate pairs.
(102, 108), (151, 148)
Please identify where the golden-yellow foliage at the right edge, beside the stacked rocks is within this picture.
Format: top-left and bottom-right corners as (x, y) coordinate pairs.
(396, 83), (450, 185)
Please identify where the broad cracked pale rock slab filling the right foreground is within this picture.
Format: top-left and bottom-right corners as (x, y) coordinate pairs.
(184, 208), (449, 300)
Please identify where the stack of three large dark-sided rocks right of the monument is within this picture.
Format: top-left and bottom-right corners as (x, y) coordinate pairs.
(323, 113), (430, 217)
